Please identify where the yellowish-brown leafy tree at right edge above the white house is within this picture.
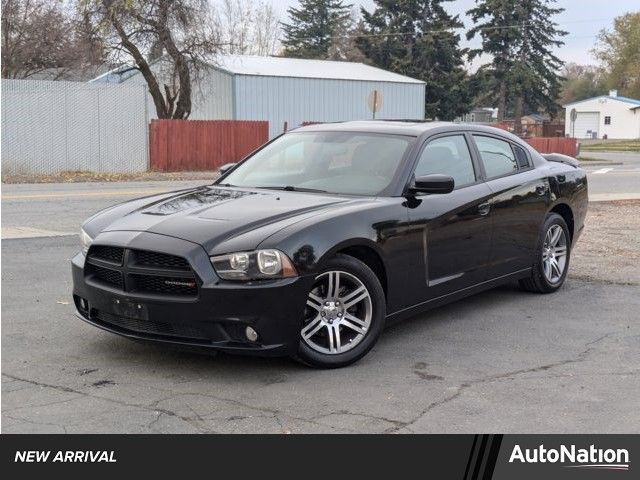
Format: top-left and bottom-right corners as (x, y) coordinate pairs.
(594, 12), (640, 98)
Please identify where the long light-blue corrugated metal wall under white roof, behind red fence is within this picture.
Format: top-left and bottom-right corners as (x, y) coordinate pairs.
(234, 75), (425, 138)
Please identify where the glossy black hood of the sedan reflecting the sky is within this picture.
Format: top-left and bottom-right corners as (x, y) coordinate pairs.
(101, 186), (357, 253)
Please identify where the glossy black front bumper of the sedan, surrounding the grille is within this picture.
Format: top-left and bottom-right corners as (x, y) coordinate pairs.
(71, 232), (314, 356)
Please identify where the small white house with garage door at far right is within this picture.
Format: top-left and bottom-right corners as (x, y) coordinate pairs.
(563, 90), (640, 139)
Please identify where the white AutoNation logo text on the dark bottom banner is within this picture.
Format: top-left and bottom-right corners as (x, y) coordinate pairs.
(509, 445), (629, 470)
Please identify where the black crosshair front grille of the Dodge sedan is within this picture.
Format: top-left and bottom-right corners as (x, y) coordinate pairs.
(85, 245), (198, 297)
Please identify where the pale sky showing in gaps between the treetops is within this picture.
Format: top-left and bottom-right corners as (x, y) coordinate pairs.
(262, 0), (640, 69)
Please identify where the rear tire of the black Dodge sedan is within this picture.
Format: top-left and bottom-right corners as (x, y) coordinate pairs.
(520, 213), (571, 293)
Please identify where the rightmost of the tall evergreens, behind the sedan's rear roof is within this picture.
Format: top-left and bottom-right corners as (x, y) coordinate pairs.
(467, 0), (567, 127)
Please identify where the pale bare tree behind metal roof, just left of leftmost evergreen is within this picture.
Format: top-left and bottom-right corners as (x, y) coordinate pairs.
(218, 0), (280, 55)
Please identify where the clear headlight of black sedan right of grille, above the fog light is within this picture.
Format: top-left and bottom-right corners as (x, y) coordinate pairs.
(211, 249), (298, 280)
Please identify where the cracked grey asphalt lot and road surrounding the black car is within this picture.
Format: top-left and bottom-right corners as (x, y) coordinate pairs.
(2, 156), (640, 433)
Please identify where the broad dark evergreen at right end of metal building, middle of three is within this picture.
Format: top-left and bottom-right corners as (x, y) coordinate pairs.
(356, 0), (471, 120)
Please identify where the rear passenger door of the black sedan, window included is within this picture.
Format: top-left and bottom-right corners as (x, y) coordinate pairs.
(472, 133), (550, 279)
